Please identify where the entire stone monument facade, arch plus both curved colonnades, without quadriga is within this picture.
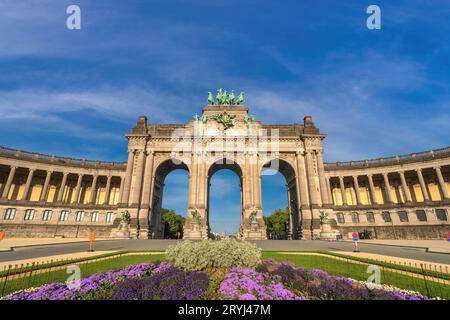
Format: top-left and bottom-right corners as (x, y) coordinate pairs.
(0, 106), (450, 239)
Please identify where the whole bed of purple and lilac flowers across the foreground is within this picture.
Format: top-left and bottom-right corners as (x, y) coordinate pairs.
(3, 259), (429, 300)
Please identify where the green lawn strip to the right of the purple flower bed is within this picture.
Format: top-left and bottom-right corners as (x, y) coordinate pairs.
(263, 252), (450, 299)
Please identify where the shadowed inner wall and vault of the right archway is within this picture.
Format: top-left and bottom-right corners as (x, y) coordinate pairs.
(260, 158), (301, 239)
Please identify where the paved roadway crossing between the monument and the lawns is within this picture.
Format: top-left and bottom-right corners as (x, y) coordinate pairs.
(0, 239), (450, 265)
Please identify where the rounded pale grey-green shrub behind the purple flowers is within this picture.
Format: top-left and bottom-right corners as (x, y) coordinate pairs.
(166, 238), (262, 273)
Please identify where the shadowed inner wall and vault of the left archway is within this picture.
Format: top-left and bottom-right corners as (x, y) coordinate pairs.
(148, 158), (190, 238)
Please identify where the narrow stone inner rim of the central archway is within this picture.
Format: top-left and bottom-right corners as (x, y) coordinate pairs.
(206, 158), (244, 236)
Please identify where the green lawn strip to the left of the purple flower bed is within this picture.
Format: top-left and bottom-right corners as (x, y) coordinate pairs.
(0, 254), (165, 296)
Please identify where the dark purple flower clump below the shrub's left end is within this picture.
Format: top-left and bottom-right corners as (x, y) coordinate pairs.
(111, 267), (208, 300)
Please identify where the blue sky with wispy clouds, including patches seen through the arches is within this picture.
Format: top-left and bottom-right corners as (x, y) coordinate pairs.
(0, 0), (450, 234)
